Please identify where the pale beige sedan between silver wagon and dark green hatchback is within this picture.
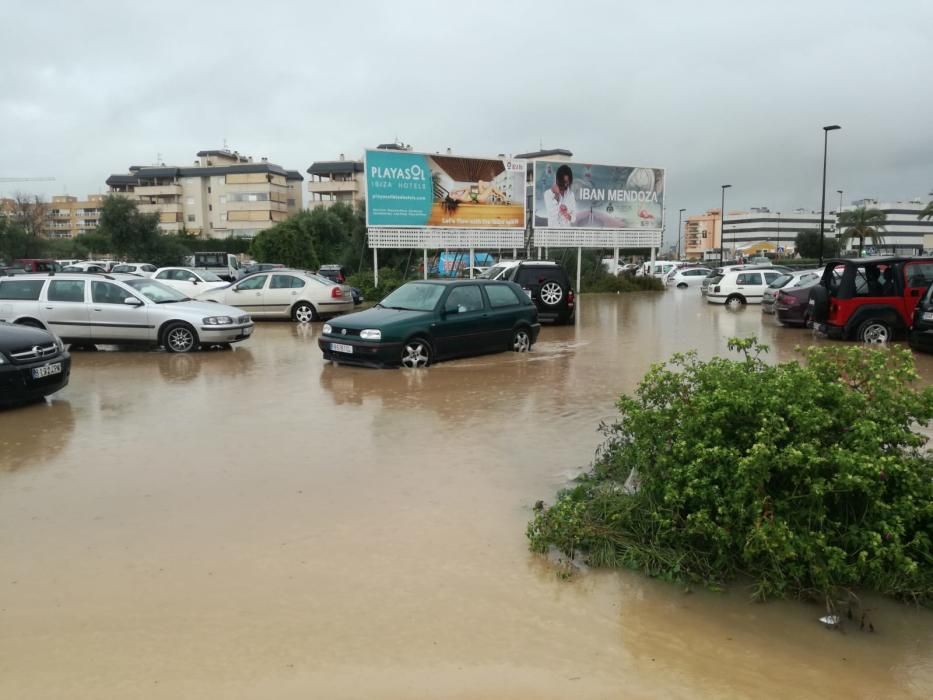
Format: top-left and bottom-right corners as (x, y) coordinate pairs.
(198, 269), (353, 323)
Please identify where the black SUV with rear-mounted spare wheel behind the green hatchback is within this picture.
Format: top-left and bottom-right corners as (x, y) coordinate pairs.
(481, 260), (576, 323)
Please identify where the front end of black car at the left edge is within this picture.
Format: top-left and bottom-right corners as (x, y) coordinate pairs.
(0, 321), (71, 406)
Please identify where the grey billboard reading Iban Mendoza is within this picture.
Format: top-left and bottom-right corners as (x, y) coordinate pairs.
(534, 160), (664, 231)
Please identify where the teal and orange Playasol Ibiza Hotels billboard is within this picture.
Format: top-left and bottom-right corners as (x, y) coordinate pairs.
(365, 150), (525, 229)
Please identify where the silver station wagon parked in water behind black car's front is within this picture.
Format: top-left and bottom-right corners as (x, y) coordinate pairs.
(0, 273), (253, 352)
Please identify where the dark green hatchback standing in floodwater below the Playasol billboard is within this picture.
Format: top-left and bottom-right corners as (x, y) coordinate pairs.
(318, 280), (541, 367)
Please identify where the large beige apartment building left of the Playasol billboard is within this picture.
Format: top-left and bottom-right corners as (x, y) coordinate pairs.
(107, 149), (304, 238)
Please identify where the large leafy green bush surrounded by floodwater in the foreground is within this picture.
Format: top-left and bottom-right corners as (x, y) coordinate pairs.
(528, 339), (933, 604)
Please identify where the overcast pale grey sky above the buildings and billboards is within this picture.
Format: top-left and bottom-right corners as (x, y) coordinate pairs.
(0, 0), (933, 245)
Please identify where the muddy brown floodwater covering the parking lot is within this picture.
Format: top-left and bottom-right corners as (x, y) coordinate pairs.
(0, 290), (933, 700)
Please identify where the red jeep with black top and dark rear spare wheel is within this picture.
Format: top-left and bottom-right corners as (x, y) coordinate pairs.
(810, 257), (933, 343)
